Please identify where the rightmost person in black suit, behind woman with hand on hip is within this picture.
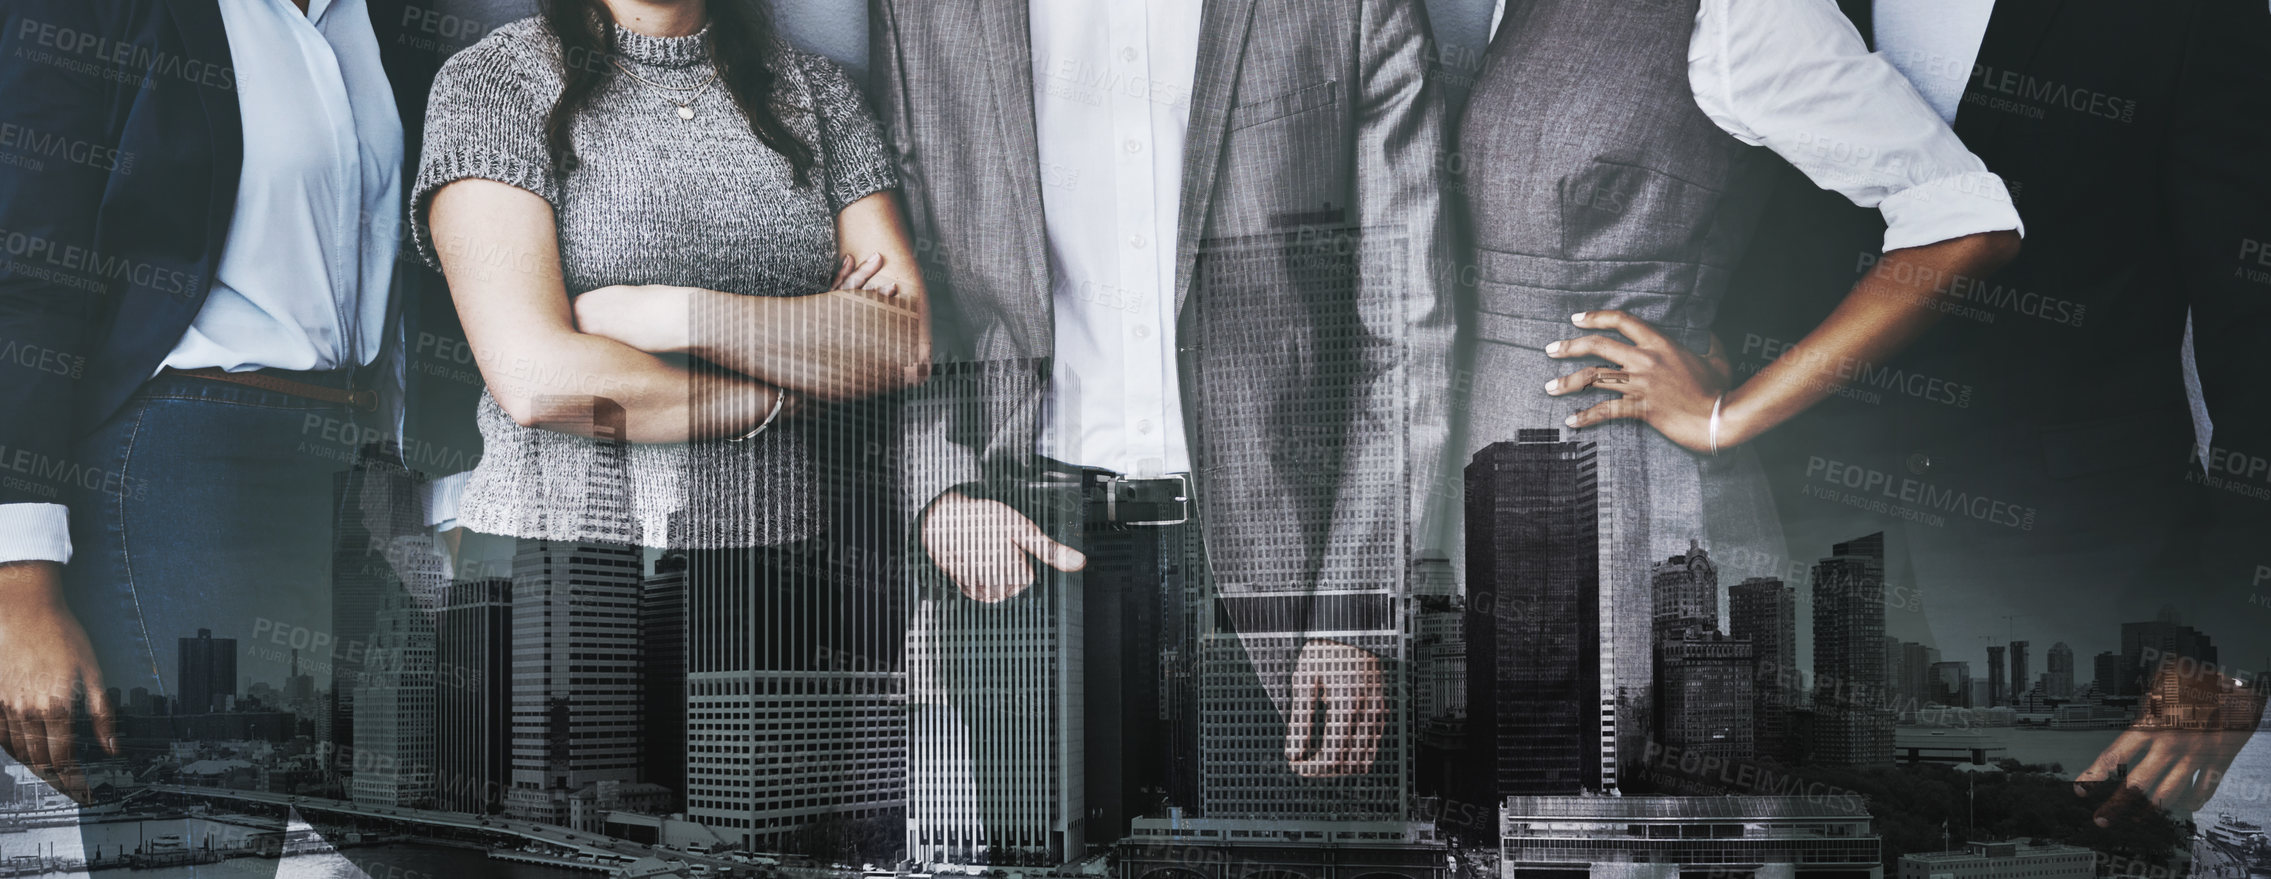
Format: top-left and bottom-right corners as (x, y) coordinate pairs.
(1742, 0), (2271, 820)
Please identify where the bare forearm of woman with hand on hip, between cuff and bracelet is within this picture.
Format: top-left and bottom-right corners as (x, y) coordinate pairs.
(1719, 232), (2019, 445)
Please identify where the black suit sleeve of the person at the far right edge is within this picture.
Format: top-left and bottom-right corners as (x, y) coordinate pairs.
(2164, 0), (2271, 558)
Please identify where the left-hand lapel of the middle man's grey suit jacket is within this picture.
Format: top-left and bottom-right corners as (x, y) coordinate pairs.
(979, 0), (1054, 350)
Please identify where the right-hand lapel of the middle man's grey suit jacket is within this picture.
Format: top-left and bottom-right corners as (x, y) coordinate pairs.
(1174, 0), (1256, 316)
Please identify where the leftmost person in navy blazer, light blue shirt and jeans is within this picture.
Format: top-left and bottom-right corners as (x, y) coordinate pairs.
(0, 0), (417, 844)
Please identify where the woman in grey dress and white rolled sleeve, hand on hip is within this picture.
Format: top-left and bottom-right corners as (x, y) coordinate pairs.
(1458, 0), (2019, 802)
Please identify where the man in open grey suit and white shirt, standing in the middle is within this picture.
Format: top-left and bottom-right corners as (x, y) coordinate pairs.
(870, 0), (1451, 863)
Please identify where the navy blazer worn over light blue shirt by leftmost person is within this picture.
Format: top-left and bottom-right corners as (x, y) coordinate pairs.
(0, 0), (438, 504)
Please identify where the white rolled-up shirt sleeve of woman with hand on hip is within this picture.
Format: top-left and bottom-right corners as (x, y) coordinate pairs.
(1492, 0), (2023, 250)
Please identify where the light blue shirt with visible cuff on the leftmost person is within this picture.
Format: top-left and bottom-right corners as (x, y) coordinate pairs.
(0, 0), (402, 561)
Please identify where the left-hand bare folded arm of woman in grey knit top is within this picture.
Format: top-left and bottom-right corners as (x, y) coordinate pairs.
(429, 179), (781, 443)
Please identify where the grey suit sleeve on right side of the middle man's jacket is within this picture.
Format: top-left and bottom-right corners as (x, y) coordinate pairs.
(1308, 0), (1456, 634)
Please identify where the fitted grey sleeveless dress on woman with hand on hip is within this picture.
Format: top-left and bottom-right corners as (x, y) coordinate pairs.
(1458, 0), (1787, 754)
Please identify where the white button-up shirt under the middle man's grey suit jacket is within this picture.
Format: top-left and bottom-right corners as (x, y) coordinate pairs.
(1029, 0), (1201, 475)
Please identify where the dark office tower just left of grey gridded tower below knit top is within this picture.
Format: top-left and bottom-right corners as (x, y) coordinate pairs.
(434, 577), (513, 815)
